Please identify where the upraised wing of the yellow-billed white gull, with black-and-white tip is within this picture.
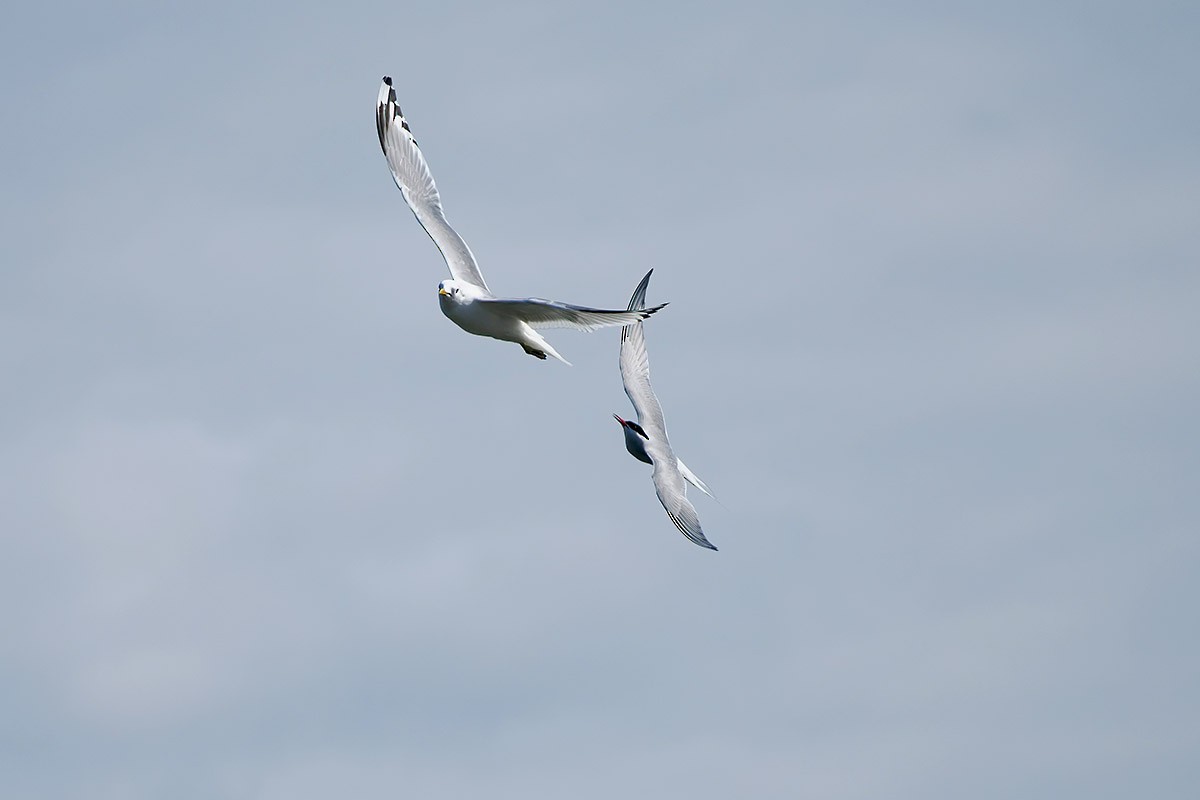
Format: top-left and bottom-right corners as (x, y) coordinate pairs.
(376, 77), (488, 291)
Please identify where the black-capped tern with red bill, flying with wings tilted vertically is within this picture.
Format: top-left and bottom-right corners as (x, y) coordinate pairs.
(613, 270), (716, 551)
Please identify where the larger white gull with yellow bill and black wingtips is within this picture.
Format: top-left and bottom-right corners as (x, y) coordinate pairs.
(376, 76), (666, 366)
